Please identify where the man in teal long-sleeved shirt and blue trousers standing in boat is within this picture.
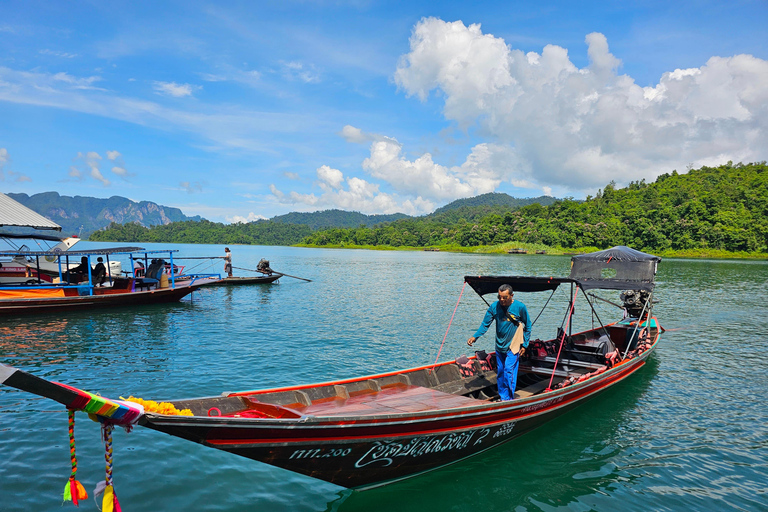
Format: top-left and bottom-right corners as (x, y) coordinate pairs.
(467, 284), (531, 400)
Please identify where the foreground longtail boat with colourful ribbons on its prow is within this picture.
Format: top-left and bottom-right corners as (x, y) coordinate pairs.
(0, 247), (663, 489)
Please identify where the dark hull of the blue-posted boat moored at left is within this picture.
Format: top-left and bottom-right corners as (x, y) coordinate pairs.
(0, 280), (214, 316)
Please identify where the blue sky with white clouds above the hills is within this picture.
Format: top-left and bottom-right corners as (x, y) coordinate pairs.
(0, 0), (768, 222)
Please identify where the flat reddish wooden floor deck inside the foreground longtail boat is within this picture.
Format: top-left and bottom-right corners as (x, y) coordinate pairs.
(296, 385), (479, 416)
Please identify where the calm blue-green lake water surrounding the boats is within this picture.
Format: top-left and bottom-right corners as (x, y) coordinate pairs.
(0, 242), (768, 512)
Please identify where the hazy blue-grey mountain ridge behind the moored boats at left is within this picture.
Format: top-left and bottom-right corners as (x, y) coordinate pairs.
(7, 192), (201, 238)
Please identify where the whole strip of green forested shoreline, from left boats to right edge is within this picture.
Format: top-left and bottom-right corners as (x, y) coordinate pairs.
(90, 162), (768, 260)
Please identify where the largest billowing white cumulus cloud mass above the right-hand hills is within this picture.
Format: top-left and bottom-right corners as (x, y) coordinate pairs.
(396, 18), (768, 192)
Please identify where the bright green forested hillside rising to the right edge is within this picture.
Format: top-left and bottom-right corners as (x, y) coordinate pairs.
(304, 162), (768, 252)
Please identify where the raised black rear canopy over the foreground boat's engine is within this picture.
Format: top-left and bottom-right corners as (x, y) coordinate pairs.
(569, 245), (661, 291)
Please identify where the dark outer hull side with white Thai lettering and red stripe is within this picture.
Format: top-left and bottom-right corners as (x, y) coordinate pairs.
(140, 337), (658, 488)
